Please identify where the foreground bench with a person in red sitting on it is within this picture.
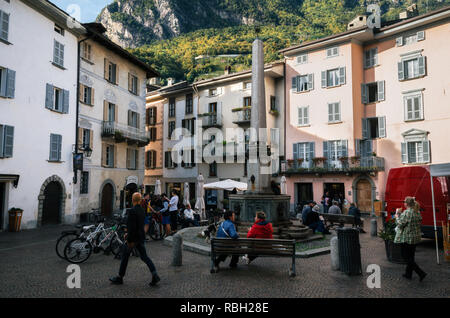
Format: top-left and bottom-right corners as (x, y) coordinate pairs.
(211, 238), (296, 277)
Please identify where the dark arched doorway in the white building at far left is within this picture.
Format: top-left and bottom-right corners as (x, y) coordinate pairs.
(41, 181), (63, 225)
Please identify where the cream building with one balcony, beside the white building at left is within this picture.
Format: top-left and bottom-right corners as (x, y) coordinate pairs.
(74, 23), (157, 219)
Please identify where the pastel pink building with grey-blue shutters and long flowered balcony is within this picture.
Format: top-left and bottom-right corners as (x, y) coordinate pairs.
(281, 7), (450, 212)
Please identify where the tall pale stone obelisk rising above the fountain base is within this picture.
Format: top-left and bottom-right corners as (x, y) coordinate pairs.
(248, 39), (270, 193)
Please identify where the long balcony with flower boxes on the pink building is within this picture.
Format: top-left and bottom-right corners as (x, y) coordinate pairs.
(281, 157), (384, 175)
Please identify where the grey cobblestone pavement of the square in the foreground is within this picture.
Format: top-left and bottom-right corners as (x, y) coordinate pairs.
(0, 221), (450, 298)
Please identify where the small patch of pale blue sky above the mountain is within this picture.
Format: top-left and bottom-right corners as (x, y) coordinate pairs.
(50, 0), (113, 23)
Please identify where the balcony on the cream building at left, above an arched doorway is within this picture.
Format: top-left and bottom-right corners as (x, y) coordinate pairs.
(102, 121), (150, 147)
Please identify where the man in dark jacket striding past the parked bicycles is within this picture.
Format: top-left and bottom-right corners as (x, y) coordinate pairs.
(109, 192), (160, 286)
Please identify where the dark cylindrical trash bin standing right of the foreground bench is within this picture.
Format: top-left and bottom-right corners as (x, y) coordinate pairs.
(337, 227), (362, 275)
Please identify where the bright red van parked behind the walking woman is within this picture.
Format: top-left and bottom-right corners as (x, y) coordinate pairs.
(385, 166), (450, 240)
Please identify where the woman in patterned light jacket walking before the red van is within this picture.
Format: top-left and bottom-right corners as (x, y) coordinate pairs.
(394, 197), (427, 281)
